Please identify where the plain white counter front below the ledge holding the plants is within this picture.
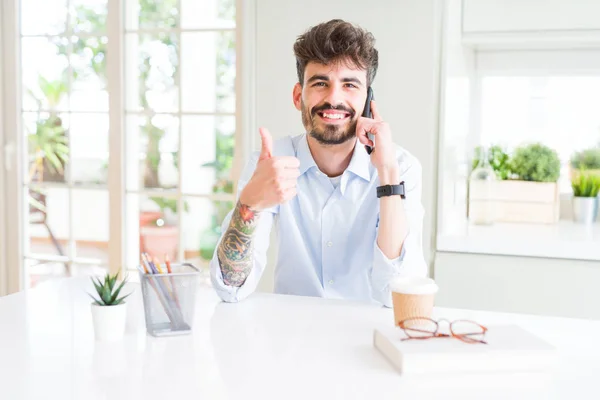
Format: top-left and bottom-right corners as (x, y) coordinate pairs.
(436, 252), (600, 319)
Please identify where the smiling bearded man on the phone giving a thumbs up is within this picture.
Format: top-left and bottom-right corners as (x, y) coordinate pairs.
(210, 20), (427, 307)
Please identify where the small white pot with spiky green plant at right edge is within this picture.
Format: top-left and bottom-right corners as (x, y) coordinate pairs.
(571, 170), (600, 224)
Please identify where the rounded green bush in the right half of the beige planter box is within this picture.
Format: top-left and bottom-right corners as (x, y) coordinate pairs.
(510, 143), (560, 182)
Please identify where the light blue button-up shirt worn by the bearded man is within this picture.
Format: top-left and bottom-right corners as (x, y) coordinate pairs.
(210, 134), (427, 307)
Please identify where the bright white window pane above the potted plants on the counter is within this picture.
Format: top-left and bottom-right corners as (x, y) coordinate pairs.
(481, 76), (600, 192)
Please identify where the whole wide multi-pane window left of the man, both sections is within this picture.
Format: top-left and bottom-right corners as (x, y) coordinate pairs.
(9, 0), (236, 287)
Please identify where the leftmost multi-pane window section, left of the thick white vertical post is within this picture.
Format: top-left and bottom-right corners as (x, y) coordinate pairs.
(20, 0), (109, 286)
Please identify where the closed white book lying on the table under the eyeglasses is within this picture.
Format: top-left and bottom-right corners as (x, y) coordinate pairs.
(373, 325), (557, 373)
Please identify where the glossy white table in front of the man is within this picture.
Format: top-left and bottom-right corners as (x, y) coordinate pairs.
(0, 279), (600, 400)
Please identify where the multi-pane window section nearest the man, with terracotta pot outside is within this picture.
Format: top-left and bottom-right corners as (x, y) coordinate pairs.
(125, 0), (235, 272)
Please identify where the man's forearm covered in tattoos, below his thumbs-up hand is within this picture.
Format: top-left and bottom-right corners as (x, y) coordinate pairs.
(217, 201), (260, 286)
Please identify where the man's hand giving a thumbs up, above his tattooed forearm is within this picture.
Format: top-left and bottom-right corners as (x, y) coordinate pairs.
(240, 128), (300, 211)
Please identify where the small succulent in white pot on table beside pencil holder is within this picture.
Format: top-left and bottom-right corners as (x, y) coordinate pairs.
(90, 273), (131, 341)
